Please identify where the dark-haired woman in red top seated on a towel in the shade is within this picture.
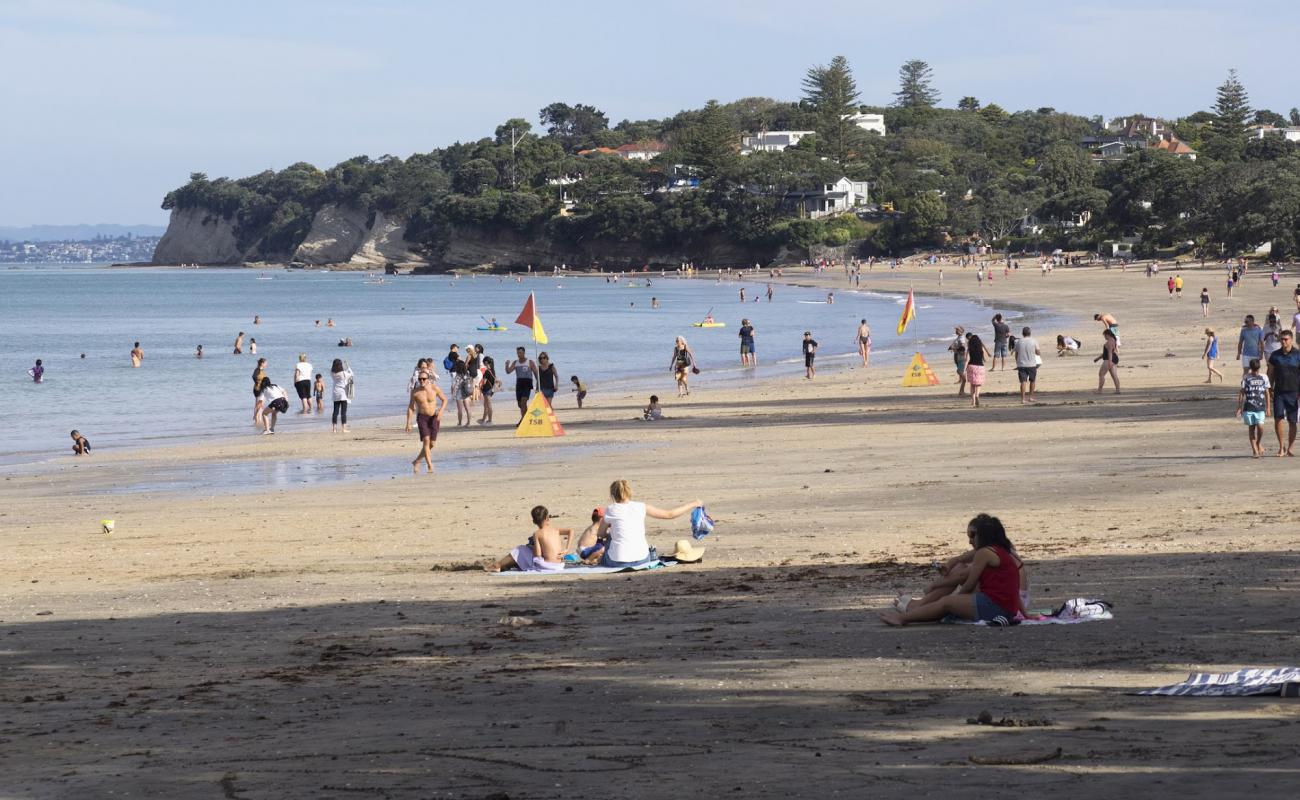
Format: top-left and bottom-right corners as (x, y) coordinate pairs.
(880, 514), (1028, 626)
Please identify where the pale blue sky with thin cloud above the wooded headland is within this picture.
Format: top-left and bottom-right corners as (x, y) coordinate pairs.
(0, 0), (1300, 225)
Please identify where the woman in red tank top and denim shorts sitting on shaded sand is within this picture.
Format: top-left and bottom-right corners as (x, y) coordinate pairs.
(880, 514), (1021, 626)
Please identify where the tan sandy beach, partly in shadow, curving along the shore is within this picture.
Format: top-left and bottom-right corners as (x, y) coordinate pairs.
(0, 259), (1300, 800)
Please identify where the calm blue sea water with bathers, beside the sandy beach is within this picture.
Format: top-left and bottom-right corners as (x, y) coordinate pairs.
(0, 265), (1034, 463)
